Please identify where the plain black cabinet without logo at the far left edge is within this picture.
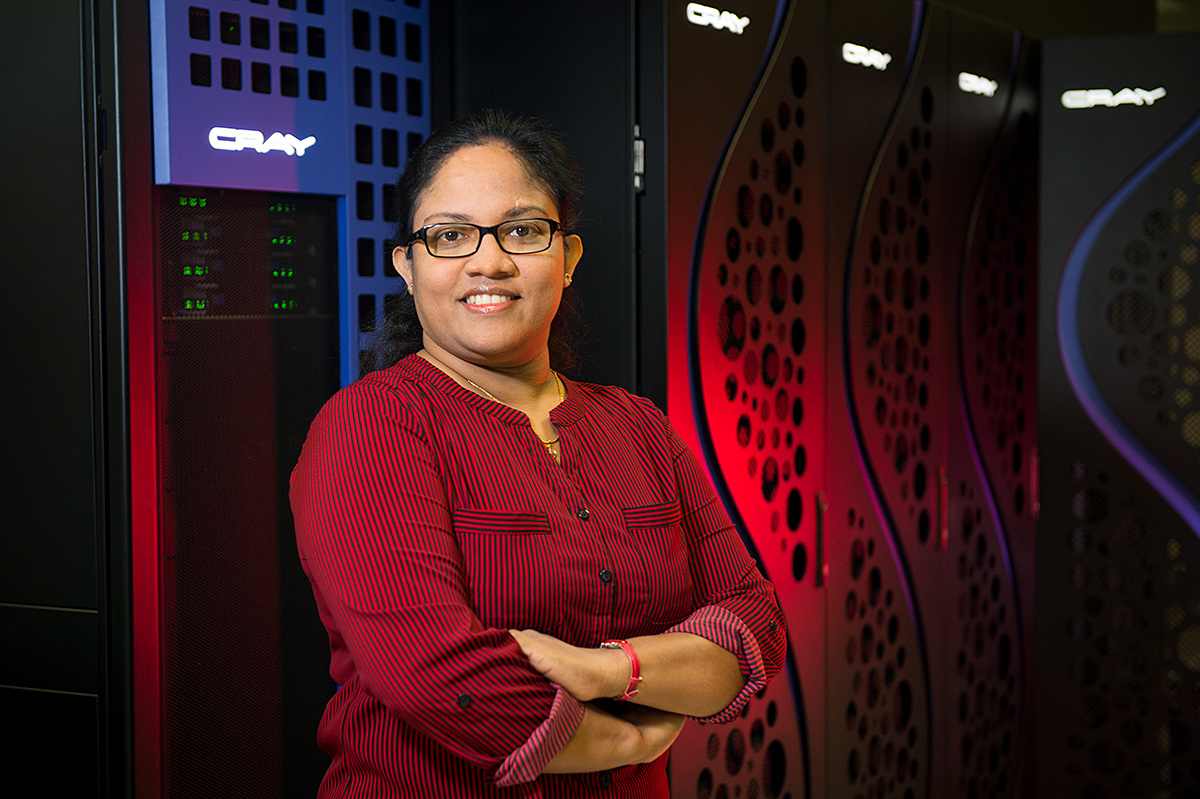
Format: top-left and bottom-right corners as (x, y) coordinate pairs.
(0, 1), (132, 797)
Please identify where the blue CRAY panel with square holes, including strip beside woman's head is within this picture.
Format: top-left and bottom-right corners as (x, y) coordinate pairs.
(150, 0), (430, 383)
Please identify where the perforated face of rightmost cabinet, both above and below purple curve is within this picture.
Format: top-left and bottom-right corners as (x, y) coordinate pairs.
(1046, 143), (1200, 797)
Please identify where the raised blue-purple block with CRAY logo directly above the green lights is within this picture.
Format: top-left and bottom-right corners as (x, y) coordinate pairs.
(151, 0), (350, 194)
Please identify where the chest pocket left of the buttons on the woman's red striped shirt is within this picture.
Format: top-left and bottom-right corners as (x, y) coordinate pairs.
(452, 510), (563, 635)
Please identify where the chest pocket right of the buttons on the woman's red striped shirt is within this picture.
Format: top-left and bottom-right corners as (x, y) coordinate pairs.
(623, 501), (695, 626)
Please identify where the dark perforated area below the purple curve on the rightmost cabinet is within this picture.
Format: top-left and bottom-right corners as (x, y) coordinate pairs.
(1048, 462), (1200, 799)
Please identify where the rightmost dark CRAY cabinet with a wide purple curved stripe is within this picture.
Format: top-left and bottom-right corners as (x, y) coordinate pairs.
(1037, 34), (1200, 799)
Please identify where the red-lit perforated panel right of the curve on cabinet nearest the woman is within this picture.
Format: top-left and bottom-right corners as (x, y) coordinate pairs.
(672, 4), (824, 799)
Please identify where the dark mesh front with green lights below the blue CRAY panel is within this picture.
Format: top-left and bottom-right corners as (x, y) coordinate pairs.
(158, 186), (337, 798)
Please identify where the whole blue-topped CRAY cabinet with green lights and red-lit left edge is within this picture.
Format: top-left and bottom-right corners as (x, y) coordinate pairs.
(125, 0), (430, 797)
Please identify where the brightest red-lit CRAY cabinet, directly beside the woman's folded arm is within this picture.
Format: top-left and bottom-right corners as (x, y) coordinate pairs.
(672, 2), (827, 798)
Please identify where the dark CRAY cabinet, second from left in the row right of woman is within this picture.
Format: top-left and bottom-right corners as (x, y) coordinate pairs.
(826, 4), (948, 797)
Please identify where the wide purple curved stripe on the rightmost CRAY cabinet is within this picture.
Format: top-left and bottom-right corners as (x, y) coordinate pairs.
(1057, 114), (1200, 535)
